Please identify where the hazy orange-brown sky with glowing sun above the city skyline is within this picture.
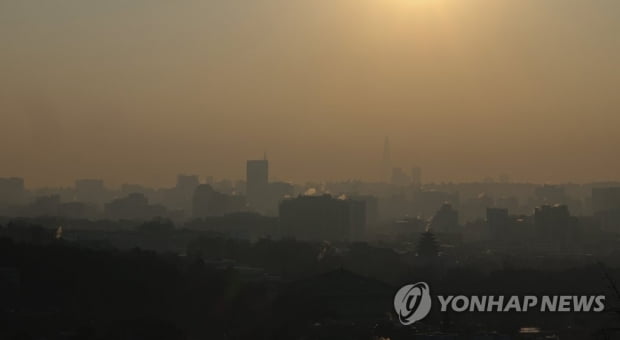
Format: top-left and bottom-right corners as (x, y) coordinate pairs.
(0, 0), (620, 187)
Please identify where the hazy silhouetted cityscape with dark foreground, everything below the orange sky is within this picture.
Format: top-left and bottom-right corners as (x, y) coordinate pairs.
(0, 159), (620, 339)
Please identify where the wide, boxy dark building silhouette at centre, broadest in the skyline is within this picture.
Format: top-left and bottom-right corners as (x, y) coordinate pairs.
(280, 195), (366, 241)
